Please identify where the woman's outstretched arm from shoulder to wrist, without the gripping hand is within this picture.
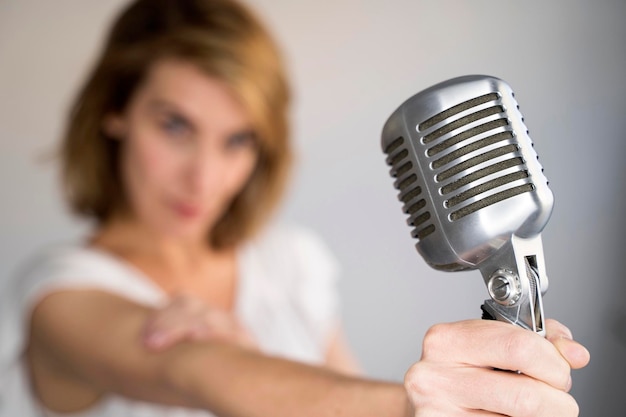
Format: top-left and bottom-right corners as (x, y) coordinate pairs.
(28, 291), (408, 417)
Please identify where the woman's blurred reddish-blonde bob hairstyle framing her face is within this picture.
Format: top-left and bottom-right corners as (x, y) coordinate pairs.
(61, 0), (291, 248)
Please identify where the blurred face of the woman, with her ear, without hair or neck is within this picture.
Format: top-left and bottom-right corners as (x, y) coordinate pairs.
(105, 60), (257, 239)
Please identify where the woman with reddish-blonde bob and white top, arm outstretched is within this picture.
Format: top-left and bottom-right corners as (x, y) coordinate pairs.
(2, 0), (588, 417)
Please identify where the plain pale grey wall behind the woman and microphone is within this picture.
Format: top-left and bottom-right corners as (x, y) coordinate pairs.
(0, 0), (626, 416)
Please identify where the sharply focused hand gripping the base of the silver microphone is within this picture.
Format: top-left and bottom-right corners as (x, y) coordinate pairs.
(405, 319), (589, 417)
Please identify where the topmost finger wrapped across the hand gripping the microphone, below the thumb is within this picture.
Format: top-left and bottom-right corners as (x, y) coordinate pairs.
(422, 320), (571, 390)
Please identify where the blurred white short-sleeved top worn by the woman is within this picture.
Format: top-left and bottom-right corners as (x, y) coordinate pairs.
(0, 227), (339, 417)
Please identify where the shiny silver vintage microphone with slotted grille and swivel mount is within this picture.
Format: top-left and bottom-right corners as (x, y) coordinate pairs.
(382, 75), (554, 336)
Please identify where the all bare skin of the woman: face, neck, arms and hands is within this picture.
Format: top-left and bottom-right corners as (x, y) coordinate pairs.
(27, 61), (589, 417)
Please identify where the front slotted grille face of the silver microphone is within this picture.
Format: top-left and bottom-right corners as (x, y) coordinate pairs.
(417, 92), (534, 222)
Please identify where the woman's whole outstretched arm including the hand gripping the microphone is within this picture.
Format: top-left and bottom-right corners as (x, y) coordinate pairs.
(29, 291), (589, 417)
